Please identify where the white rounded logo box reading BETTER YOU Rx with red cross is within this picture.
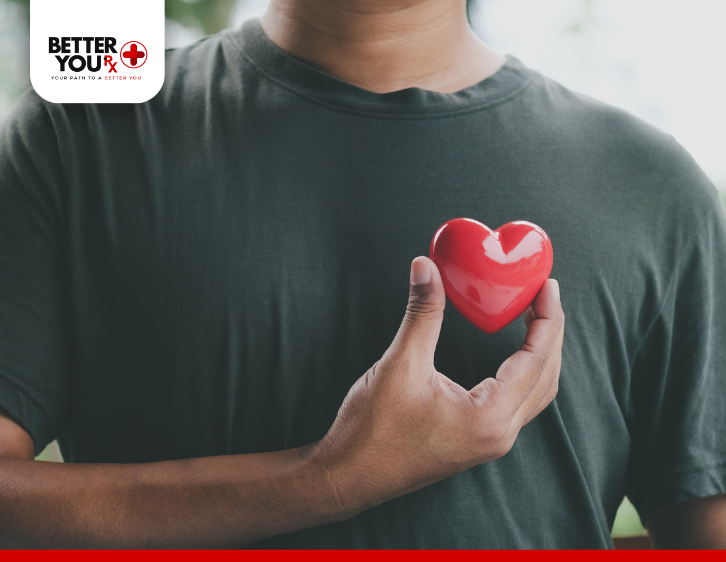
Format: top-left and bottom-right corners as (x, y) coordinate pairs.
(30, 0), (164, 103)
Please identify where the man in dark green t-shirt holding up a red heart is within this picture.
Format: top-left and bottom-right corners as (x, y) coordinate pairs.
(0, 0), (726, 548)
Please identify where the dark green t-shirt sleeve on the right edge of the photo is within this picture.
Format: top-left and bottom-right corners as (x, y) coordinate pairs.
(627, 199), (726, 518)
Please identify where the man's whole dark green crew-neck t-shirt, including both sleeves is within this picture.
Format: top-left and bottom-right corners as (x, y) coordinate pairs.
(0, 20), (726, 548)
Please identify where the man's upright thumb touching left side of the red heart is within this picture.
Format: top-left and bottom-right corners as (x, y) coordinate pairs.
(391, 257), (446, 365)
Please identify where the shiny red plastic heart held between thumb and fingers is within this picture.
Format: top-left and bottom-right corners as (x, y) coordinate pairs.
(429, 219), (552, 334)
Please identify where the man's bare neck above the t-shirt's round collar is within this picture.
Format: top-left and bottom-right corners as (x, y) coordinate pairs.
(261, 0), (505, 93)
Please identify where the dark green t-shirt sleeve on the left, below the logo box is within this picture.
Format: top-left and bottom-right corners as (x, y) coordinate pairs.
(0, 92), (70, 454)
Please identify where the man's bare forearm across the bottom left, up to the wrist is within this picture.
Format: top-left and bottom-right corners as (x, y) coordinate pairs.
(0, 449), (346, 548)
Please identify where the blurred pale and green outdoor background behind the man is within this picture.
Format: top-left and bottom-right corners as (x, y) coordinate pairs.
(0, 0), (726, 536)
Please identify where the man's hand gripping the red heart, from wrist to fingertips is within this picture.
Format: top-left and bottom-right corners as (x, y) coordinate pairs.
(308, 257), (564, 515)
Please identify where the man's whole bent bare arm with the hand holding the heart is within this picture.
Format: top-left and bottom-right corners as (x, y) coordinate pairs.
(0, 258), (564, 548)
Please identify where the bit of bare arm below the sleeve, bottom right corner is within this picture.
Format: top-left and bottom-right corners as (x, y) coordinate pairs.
(646, 494), (726, 549)
